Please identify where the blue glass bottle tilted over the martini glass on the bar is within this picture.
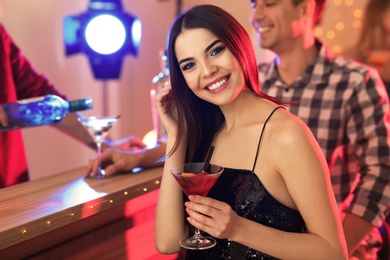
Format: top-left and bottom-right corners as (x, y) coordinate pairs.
(0, 95), (92, 132)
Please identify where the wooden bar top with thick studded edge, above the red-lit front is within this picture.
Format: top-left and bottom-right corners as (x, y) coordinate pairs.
(0, 167), (162, 259)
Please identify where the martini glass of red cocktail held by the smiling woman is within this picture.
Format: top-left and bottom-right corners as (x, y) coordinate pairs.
(171, 163), (223, 250)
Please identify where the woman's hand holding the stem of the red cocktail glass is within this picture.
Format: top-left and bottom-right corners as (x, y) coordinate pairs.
(185, 195), (240, 239)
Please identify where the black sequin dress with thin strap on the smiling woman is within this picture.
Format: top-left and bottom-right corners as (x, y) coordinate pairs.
(186, 106), (306, 260)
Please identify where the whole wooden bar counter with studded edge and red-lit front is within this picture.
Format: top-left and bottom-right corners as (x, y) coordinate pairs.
(0, 167), (174, 259)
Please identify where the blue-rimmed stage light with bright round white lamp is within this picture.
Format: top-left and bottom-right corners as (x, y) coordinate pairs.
(63, 0), (141, 79)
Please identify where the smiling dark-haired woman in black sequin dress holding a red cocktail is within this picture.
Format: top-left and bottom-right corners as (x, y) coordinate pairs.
(155, 5), (346, 259)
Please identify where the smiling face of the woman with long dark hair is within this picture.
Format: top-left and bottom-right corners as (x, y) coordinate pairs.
(174, 28), (245, 105)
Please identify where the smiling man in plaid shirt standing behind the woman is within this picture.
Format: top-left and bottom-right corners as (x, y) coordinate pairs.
(251, 0), (390, 259)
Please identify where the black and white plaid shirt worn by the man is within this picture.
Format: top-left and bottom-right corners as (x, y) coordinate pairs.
(259, 40), (390, 226)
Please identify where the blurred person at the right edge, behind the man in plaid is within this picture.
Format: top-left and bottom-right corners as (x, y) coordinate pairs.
(345, 0), (390, 94)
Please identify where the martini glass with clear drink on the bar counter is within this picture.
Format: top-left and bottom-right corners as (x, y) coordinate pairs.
(79, 116), (120, 180)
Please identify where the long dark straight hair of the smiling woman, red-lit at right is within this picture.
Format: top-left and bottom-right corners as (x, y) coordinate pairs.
(167, 5), (279, 162)
